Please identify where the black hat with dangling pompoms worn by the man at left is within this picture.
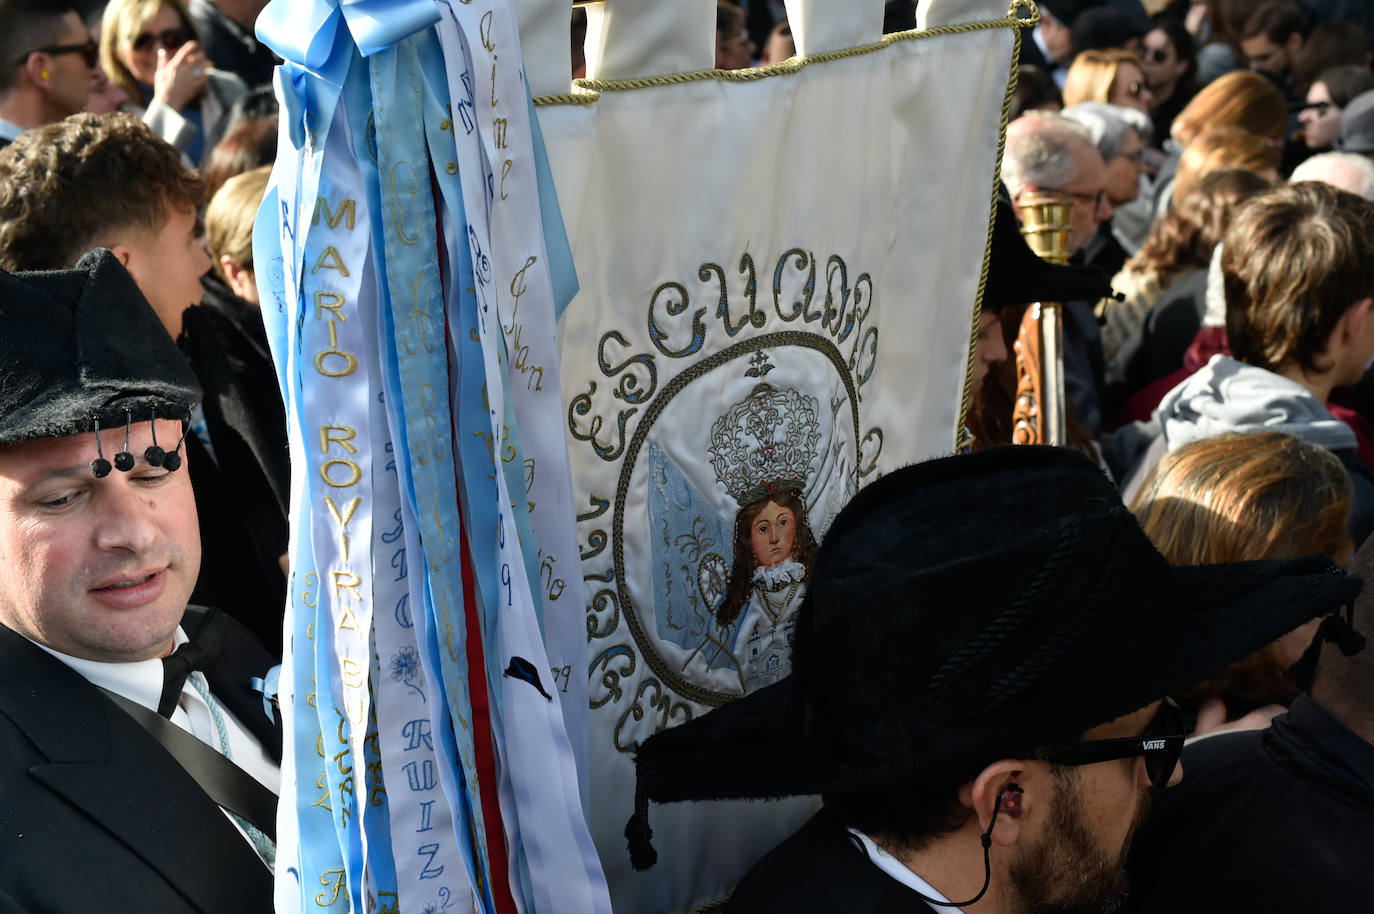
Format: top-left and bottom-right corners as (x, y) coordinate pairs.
(0, 249), (201, 445)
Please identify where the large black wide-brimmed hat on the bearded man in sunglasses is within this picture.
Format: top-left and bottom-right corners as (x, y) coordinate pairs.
(625, 447), (1360, 869)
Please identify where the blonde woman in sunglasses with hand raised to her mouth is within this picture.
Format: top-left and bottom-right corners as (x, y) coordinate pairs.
(100, 0), (247, 166)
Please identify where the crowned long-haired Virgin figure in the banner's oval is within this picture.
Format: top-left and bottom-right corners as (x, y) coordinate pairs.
(710, 383), (820, 693)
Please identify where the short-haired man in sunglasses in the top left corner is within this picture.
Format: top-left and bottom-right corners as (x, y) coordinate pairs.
(0, 0), (96, 147)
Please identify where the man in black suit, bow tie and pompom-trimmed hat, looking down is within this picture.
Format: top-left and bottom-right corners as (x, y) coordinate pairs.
(0, 250), (282, 914)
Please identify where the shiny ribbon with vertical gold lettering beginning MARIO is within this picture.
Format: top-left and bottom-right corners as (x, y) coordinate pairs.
(295, 100), (393, 904)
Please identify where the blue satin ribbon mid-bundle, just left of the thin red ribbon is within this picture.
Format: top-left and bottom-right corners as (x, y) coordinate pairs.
(359, 34), (495, 911)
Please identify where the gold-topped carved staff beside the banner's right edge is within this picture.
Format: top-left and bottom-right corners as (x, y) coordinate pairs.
(1011, 191), (1073, 445)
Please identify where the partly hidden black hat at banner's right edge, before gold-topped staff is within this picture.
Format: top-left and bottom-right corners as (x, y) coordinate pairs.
(982, 194), (1112, 313)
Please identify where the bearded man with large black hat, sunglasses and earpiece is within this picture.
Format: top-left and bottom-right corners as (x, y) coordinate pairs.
(625, 447), (1359, 914)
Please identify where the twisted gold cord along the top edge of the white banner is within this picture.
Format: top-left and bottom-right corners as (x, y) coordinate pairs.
(534, 0), (1040, 105)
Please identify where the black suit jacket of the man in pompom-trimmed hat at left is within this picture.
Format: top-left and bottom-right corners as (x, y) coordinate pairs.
(0, 609), (282, 914)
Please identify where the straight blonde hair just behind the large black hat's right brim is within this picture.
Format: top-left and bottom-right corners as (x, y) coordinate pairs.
(1131, 432), (1355, 704)
